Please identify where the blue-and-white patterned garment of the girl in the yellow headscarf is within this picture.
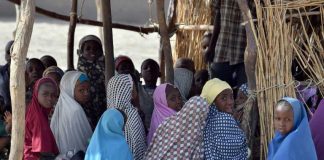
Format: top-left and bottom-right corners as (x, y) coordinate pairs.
(204, 105), (248, 160)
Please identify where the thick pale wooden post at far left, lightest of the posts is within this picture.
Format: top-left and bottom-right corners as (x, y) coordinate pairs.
(9, 0), (35, 160)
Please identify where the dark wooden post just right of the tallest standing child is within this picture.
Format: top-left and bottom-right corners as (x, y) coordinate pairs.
(101, 0), (115, 84)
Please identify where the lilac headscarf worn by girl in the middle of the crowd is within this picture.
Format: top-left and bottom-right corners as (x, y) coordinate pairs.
(147, 83), (177, 144)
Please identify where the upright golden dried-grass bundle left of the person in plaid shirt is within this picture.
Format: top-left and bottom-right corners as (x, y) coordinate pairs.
(173, 0), (212, 70)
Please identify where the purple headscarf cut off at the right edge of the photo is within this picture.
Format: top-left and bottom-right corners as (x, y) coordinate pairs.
(309, 99), (324, 160)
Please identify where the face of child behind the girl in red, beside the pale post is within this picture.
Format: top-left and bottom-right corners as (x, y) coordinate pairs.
(26, 63), (44, 83)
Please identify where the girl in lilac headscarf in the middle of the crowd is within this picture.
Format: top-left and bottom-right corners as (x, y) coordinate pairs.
(147, 84), (182, 144)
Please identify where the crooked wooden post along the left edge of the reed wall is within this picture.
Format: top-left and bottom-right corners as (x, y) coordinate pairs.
(236, 0), (259, 159)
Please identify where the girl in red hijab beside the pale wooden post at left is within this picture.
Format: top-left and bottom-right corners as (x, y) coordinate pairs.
(24, 78), (58, 160)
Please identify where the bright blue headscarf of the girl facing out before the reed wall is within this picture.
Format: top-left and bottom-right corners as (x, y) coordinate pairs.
(268, 97), (317, 160)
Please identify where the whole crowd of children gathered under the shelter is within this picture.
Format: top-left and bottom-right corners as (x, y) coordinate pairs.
(0, 32), (324, 160)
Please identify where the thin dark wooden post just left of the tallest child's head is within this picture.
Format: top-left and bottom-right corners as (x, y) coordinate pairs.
(67, 0), (78, 70)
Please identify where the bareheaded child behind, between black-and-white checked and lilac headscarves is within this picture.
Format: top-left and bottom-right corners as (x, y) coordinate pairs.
(138, 59), (160, 129)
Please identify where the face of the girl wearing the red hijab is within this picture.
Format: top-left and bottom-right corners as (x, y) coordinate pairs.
(37, 82), (57, 108)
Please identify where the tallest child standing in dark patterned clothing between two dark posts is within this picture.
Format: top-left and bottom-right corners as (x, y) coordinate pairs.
(78, 35), (106, 129)
